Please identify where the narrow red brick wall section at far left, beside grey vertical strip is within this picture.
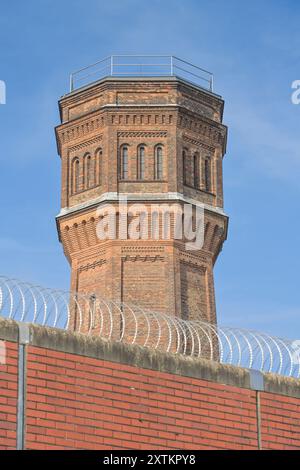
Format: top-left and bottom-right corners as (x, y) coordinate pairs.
(0, 341), (18, 450)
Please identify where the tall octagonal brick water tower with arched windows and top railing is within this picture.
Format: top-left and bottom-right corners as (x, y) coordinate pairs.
(56, 56), (228, 326)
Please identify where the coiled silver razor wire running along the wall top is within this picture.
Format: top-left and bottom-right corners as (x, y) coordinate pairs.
(0, 276), (300, 378)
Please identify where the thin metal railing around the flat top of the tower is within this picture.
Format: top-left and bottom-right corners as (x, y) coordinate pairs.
(70, 55), (213, 91)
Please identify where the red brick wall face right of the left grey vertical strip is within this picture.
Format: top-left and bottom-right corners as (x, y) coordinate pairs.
(22, 347), (300, 450)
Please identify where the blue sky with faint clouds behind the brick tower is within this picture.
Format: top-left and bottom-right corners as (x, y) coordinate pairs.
(0, 0), (300, 338)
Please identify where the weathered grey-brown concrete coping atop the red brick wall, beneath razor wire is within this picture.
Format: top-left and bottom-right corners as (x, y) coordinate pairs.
(0, 318), (300, 398)
